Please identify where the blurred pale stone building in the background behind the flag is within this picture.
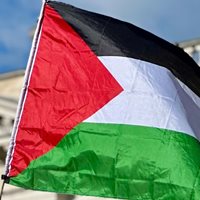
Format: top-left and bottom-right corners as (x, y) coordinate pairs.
(0, 39), (200, 200)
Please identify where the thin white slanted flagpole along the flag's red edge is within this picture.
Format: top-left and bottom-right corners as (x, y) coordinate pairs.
(0, 0), (48, 181)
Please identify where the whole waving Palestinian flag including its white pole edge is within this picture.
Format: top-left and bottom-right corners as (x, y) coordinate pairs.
(4, 1), (200, 200)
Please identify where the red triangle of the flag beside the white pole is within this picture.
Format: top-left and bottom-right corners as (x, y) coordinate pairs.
(9, 5), (123, 176)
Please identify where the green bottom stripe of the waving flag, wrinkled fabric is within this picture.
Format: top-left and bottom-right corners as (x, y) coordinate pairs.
(10, 123), (200, 200)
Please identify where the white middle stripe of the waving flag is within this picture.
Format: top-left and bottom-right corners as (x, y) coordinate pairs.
(85, 56), (200, 138)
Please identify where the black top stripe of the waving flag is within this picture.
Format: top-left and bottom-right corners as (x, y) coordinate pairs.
(48, 1), (200, 96)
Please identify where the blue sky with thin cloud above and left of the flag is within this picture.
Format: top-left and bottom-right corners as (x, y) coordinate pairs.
(0, 0), (200, 73)
